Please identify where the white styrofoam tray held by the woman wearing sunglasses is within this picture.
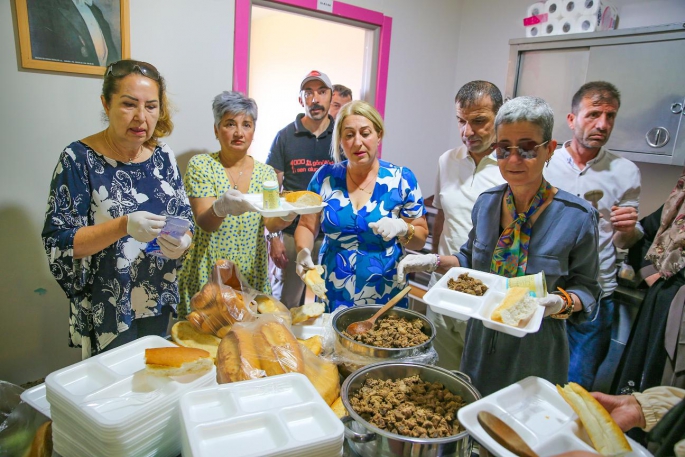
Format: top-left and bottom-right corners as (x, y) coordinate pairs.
(423, 267), (545, 338)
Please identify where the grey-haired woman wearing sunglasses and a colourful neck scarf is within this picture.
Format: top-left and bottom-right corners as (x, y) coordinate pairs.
(399, 97), (601, 395)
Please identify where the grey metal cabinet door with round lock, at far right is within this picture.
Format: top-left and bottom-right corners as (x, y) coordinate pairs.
(586, 40), (685, 165)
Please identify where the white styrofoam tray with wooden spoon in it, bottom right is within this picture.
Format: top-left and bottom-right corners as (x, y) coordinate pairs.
(457, 376), (651, 457)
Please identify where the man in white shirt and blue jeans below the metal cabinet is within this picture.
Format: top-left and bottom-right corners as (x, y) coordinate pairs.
(544, 81), (641, 390)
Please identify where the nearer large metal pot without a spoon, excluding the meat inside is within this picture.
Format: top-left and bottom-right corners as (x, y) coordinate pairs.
(341, 362), (480, 457)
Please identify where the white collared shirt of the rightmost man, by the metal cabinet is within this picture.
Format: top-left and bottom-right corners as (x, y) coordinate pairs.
(543, 141), (640, 296)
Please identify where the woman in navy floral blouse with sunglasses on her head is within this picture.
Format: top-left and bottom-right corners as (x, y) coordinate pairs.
(42, 60), (192, 358)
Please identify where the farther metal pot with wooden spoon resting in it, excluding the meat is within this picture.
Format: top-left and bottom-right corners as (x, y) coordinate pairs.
(332, 305), (435, 359)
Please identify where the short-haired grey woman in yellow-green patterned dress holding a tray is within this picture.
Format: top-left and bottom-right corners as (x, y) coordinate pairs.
(179, 92), (294, 317)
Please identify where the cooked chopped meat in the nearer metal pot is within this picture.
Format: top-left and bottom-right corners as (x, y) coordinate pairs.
(350, 375), (466, 438)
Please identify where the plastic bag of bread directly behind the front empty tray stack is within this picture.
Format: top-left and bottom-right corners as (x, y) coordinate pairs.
(216, 314), (305, 384)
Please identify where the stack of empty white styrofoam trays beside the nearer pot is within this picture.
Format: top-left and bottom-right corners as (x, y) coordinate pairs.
(181, 373), (344, 457)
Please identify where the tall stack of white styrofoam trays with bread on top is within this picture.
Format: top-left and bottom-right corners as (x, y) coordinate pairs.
(45, 336), (216, 457)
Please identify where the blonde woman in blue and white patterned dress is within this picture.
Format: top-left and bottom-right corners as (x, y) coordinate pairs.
(295, 100), (428, 311)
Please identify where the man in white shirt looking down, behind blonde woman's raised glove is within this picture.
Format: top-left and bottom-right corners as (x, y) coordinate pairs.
(426, 81), (504, 370)
